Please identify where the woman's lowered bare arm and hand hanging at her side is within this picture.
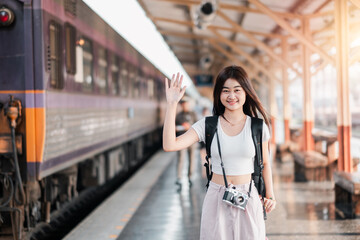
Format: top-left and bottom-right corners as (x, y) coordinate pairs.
(262, 141), (276, 212)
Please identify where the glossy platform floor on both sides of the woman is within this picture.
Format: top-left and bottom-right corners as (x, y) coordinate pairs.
(117, 151), (360, 240)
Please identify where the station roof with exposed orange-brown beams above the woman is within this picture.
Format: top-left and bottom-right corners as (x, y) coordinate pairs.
(138, 0), (360, 97)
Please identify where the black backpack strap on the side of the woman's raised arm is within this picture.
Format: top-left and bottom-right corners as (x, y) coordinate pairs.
(204, 116), (219, 188)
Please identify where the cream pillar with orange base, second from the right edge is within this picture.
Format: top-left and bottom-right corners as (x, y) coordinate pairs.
(302, 18), (314, 151)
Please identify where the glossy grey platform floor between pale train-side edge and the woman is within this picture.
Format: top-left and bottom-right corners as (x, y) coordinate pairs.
(118, 153), (206, 240)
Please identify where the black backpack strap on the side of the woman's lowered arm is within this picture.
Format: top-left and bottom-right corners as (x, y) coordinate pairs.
(251, 117), (266, 219)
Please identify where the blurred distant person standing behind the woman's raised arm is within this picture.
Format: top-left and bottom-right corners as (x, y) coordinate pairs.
(175, 97), (197, 189)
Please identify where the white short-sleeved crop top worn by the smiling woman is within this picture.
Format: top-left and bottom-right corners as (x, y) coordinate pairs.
(192, 116), (270, 175)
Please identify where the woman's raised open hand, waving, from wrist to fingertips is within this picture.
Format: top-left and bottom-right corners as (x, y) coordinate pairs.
(165, 73), (186, 103)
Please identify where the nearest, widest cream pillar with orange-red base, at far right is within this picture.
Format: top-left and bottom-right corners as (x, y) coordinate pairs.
(334, 0), (352, 172)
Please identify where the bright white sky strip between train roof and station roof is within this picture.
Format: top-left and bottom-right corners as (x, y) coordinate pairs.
(83, 0), (200, 98)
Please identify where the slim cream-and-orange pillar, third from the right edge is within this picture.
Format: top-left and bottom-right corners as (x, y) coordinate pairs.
(281, 37), (291, 143)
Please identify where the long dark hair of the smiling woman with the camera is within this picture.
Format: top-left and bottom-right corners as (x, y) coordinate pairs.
(213, 66), (269, 126)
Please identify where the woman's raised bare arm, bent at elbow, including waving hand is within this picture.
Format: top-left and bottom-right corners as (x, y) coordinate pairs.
(163, 73), (199, 151)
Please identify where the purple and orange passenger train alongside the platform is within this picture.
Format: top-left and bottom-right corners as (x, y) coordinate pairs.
(0, 0), (166, 240)
